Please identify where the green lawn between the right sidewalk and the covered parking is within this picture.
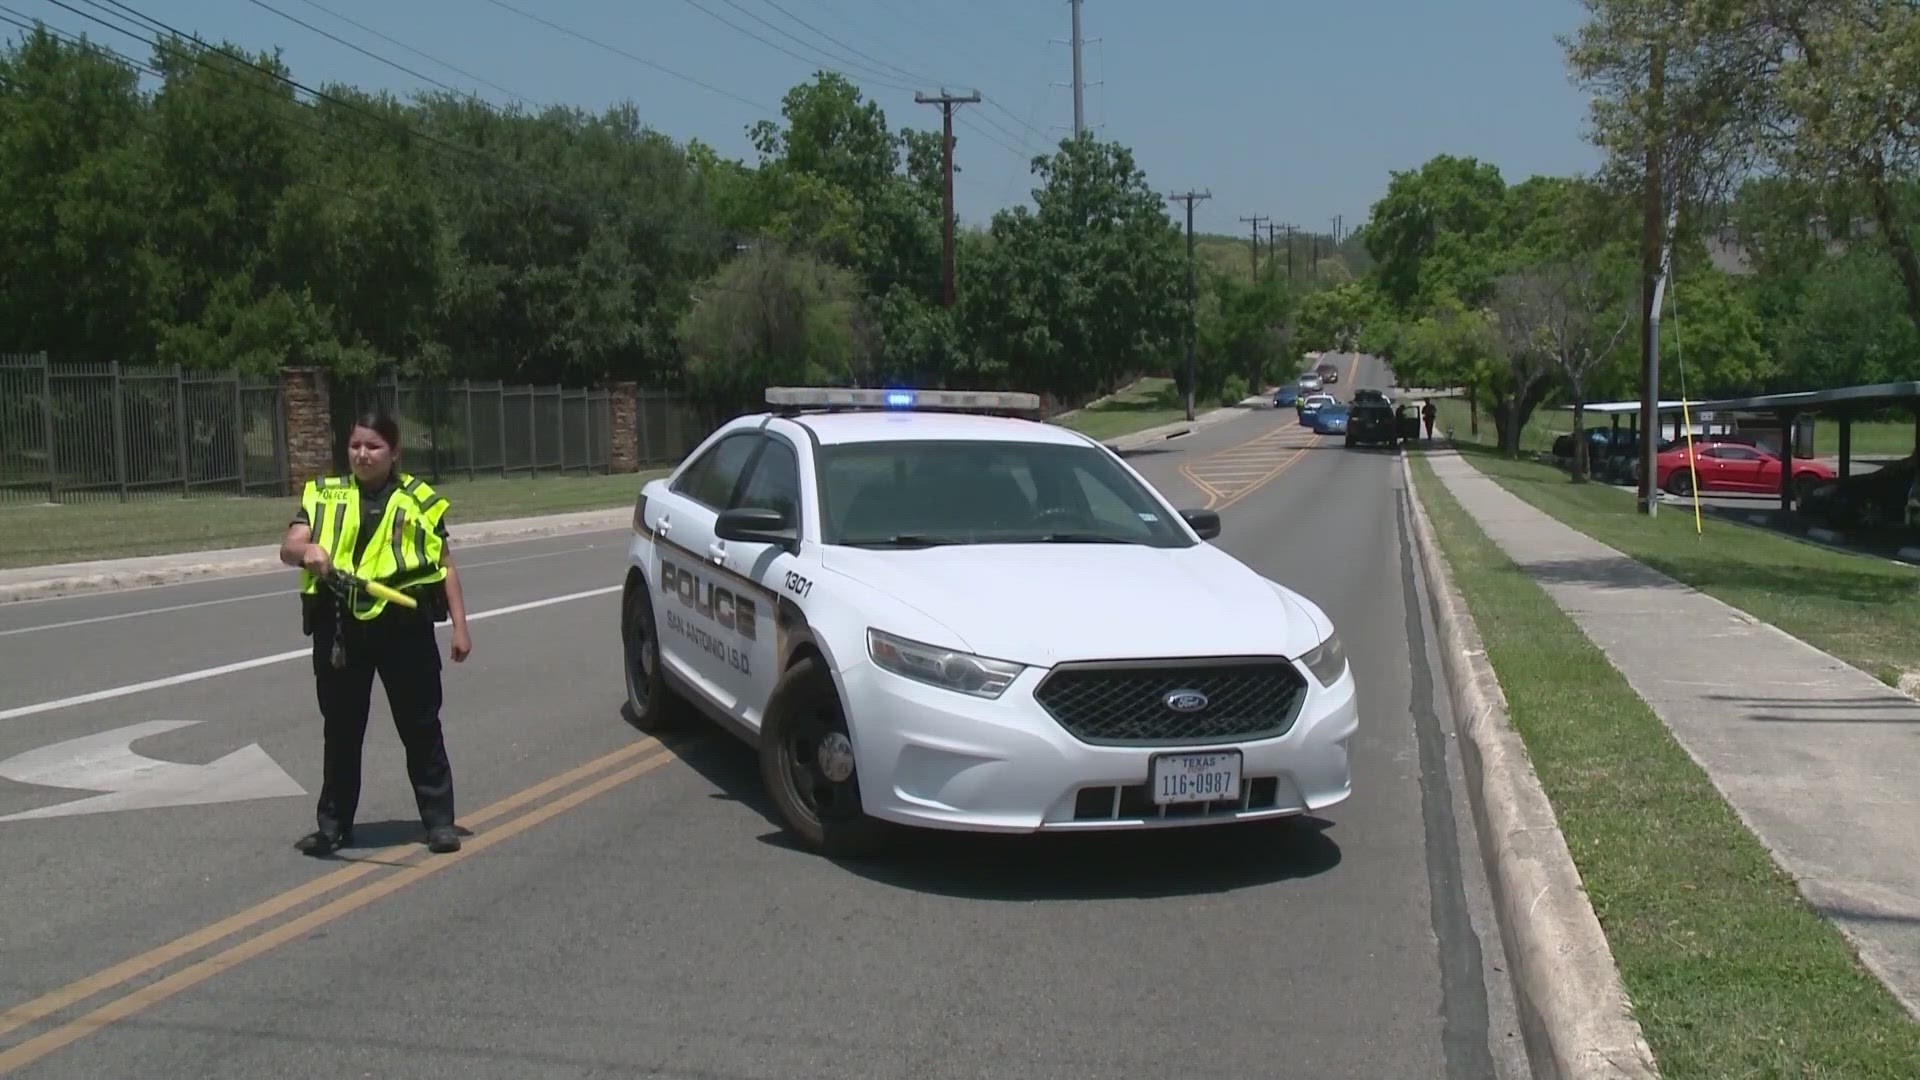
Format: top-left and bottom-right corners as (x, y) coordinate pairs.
(1436, 446), (1920, 684)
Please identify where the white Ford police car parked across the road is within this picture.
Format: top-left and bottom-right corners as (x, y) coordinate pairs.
(622, 388), (1357, 855)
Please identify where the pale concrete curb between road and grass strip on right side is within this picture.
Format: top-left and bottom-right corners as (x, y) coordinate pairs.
(1400, 455), (1659, 1080)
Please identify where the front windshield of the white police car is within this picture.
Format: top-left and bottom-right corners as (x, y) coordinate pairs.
(816, 442), (1192, 548)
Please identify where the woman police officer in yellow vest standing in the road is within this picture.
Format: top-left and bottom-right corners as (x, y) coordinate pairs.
(280, 413), (472, 855)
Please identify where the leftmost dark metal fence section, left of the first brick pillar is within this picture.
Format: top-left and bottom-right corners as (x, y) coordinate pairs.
(0, 354), (286, 502)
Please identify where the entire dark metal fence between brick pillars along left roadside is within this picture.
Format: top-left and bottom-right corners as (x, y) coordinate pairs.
(0, 354), (755, 502)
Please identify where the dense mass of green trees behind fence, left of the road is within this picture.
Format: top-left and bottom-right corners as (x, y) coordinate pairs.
(0, 31), (1221, 404)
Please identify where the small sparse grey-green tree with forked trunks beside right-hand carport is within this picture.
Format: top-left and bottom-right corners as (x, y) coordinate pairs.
(1494, 261), (1634, 470)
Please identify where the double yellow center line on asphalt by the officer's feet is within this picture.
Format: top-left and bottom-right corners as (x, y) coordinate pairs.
(0, 736), (678, 1074)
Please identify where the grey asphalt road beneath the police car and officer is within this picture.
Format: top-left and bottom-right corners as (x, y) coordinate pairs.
(0, 361), (1524, 1080)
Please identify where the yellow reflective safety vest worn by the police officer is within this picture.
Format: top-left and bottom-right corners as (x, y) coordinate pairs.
(300, 473), (447, 621)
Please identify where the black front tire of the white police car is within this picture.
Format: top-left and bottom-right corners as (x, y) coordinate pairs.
(760, 657), (893, 859)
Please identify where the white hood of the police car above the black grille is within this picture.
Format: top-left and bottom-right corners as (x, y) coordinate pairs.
(822, 544), (1331, 667)
